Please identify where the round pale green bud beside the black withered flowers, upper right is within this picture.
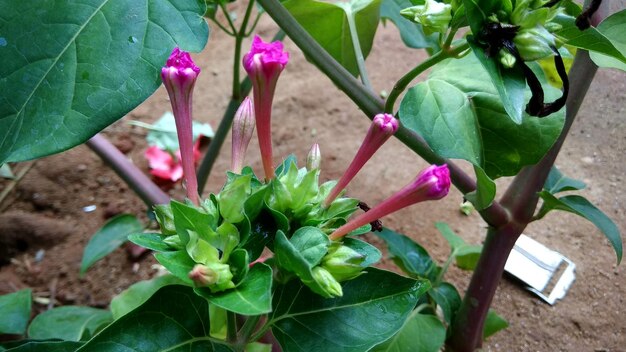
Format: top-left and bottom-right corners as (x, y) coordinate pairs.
(513, 26), (556, 61)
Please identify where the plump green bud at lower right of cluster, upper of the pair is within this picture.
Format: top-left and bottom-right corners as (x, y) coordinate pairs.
(322, 242), (365, 282)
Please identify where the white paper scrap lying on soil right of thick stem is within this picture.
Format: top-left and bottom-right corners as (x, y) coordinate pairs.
(504, 235), (576, 304)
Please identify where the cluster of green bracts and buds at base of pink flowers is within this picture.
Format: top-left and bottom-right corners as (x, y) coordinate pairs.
(130, 157), (380, 297)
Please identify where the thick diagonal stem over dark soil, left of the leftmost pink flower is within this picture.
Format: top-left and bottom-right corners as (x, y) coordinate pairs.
(86, 134), (170, 207)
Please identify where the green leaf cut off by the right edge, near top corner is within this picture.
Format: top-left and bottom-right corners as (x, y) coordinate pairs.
(590, 10), (626, 71)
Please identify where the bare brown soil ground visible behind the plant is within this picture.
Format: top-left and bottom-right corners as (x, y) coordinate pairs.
(0, 6), (626, 352)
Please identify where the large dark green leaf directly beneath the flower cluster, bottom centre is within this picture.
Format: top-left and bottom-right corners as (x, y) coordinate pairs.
(270, 268), (430, 352)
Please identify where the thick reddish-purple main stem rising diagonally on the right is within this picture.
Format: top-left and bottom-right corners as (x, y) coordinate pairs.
(448, 0), (608, 352)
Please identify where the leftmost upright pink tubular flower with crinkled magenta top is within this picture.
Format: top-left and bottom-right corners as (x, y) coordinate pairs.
(161, 48), (200, 205)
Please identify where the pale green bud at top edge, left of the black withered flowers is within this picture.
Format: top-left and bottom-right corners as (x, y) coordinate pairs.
(400, 0), (452, 35)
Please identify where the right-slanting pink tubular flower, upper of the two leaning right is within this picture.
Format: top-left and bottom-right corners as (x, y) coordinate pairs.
(324, 114), (399, 207)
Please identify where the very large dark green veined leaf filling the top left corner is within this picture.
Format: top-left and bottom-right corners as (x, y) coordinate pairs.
(0, 0), (209, 163)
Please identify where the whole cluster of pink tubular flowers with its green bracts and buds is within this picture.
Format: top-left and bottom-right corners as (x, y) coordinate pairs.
(146, 41), (450, 297)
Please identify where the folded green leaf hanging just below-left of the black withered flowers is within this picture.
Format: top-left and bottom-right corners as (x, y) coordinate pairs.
(469, 40), (526, 124)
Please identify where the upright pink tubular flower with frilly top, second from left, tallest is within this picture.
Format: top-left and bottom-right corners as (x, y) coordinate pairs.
(243, 36), (289, 180)
